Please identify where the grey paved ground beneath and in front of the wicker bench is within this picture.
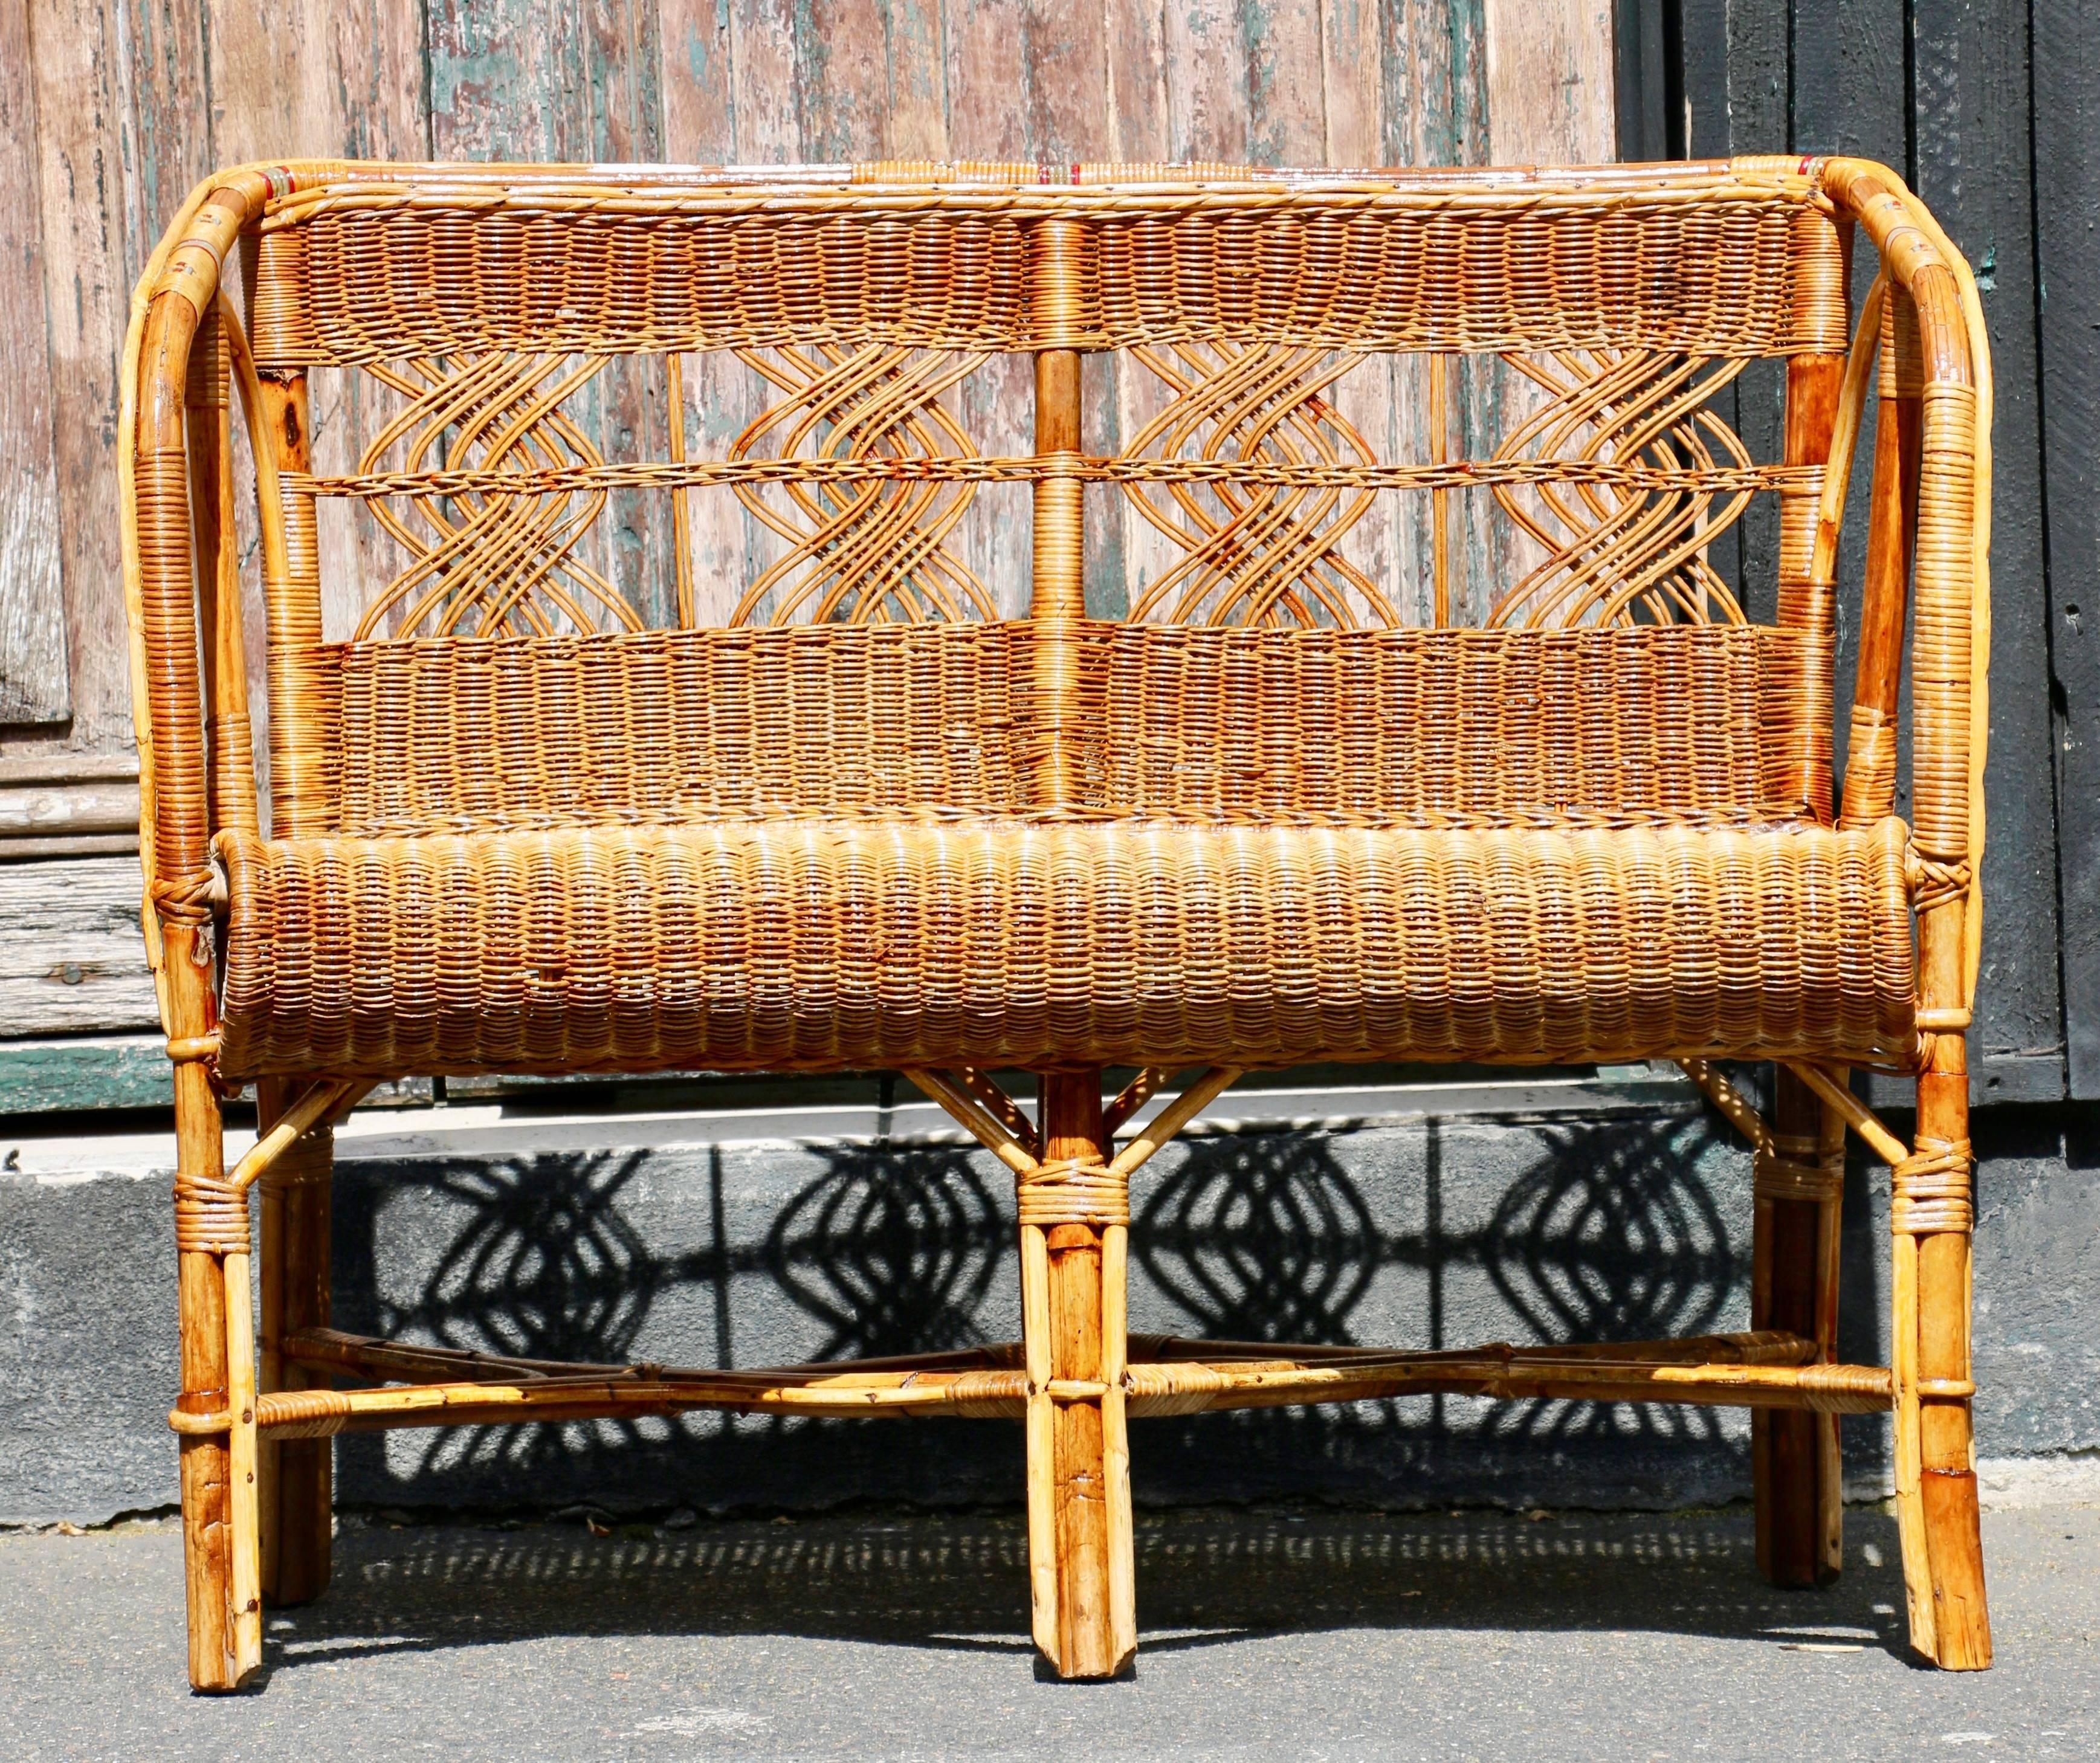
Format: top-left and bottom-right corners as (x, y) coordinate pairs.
(0, 1507), (2100, 1763)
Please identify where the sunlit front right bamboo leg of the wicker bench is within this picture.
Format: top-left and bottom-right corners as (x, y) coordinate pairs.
(1898, 1062), (1991, 1671)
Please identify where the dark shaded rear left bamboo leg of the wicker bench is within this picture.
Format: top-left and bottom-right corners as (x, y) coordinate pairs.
(258, 1083), (334, 1605)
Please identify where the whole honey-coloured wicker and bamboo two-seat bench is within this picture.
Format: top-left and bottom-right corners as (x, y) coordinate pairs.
(122, 160), (1991, 1689)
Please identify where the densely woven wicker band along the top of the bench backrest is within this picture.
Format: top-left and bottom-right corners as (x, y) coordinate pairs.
(252, 160), (1848, 369)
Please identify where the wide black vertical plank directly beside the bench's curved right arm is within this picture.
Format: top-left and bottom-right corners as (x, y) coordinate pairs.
(1913, 0), (2064, 1102)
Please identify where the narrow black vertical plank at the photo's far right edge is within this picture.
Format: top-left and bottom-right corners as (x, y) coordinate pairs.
(2032, 0), (2100, 1100)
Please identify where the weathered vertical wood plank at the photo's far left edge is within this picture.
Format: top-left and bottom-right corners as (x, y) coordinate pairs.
(0, 0), (74, 722)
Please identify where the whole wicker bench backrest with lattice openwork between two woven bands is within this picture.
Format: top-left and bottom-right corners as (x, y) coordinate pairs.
(208, 161), (1873, 833)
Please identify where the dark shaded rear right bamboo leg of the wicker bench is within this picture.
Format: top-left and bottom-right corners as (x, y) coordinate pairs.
(1749, 1068), (1842, 1587)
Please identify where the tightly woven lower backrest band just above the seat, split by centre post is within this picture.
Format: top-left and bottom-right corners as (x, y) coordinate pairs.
(311, 624), (1827, 837)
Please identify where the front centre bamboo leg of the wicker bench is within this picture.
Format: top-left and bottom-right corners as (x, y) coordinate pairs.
(1021, 1071), (1136, 1677)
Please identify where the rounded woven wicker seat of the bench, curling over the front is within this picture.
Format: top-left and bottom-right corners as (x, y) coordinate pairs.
(221, 819), (1915, 1079)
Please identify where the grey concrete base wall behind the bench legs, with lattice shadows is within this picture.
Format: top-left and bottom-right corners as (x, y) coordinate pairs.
(0, 1098), (2100, 1522)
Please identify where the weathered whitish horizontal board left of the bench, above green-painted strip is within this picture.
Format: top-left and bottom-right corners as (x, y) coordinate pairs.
(0, 856), (160, 1037)
